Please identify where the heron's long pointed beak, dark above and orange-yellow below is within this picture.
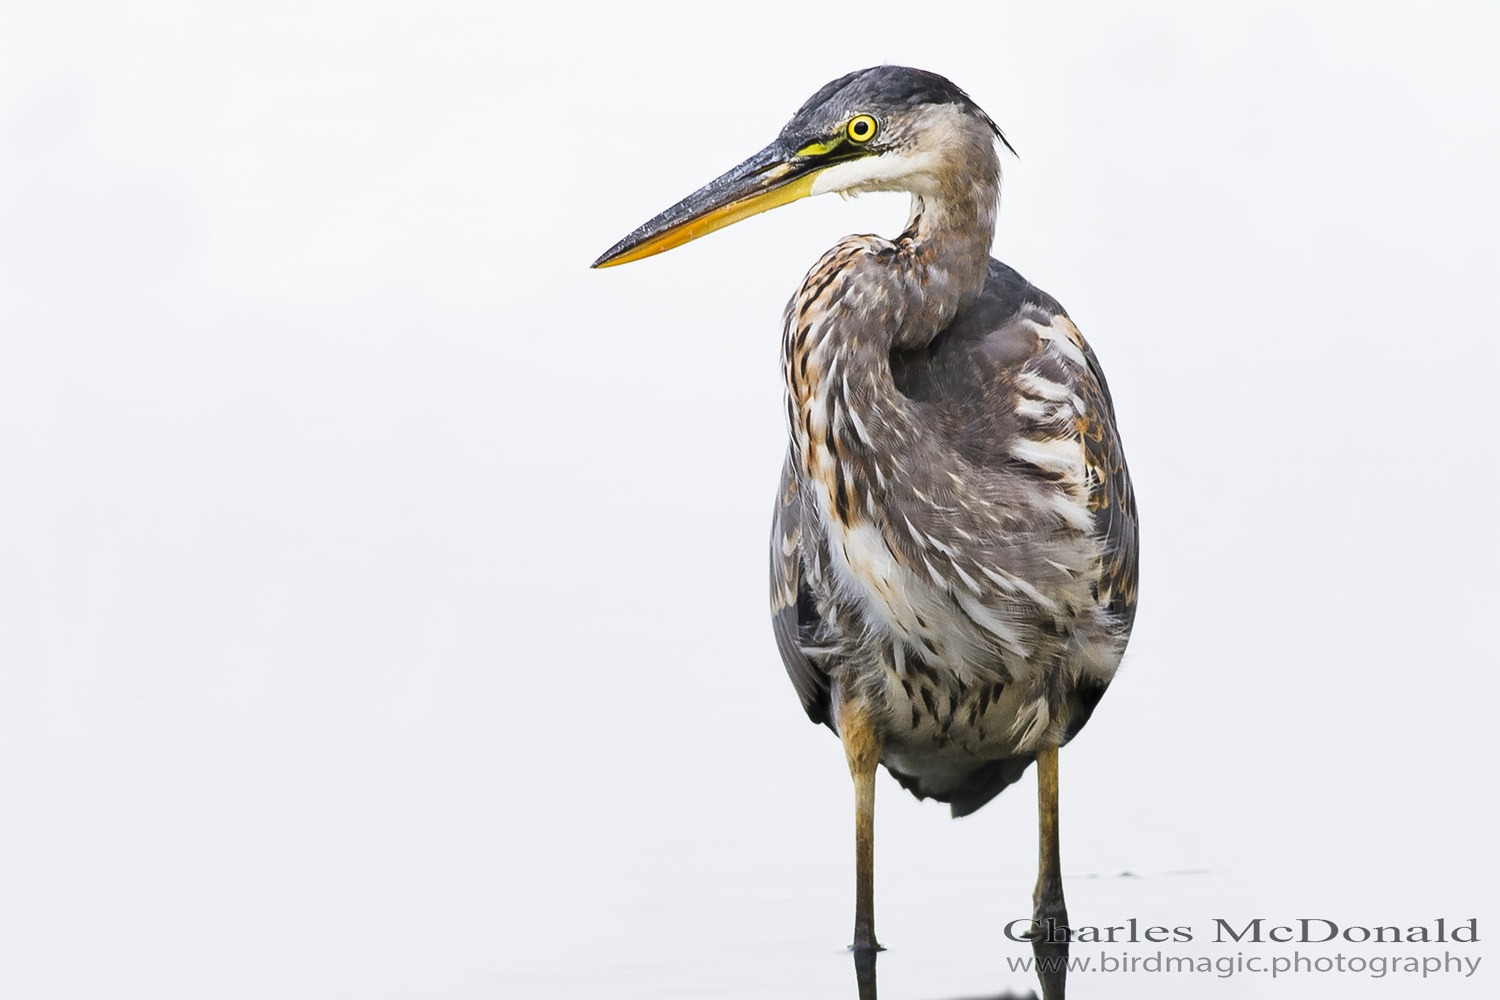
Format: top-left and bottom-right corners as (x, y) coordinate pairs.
(593, 139), (837, 267)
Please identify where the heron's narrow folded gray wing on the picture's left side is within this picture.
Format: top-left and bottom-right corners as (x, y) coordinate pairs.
(771, 456), (833, 726)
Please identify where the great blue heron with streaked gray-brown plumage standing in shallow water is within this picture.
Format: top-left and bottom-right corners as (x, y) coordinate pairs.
(594, 66), (1137, 999)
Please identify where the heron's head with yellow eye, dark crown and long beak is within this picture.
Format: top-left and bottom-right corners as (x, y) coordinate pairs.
(594, 66), (1010, 267)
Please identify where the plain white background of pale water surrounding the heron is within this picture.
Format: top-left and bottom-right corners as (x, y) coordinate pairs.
(0, 0), (1500, 1000)
